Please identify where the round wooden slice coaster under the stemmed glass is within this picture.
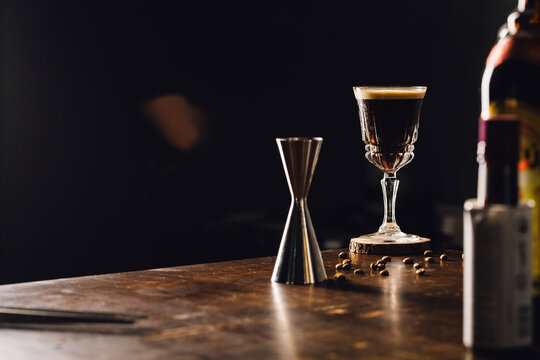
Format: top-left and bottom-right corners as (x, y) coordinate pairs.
(349, 237), (431, 255)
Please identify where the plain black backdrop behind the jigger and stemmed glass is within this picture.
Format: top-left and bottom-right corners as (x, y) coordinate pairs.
(0, 0), (516, 282)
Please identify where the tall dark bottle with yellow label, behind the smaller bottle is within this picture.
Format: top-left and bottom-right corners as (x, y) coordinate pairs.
(481, 0), (540, 293)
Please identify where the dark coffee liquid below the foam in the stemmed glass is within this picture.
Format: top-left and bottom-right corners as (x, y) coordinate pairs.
(358, 98), (423, 171)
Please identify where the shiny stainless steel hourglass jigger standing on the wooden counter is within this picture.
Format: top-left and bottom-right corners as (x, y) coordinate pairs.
(272, 137), (326, 284)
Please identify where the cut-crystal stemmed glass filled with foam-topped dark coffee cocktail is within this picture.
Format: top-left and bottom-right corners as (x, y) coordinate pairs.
(350, 86), (429, 252)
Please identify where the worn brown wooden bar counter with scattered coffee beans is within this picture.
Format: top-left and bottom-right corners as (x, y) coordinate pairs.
(0, 251), (540, 360)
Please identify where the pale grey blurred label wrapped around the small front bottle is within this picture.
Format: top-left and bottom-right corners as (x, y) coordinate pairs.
(463, 199), (532, 349)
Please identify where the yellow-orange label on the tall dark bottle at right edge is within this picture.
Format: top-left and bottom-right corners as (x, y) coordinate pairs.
(489, 99), (540, 294)
